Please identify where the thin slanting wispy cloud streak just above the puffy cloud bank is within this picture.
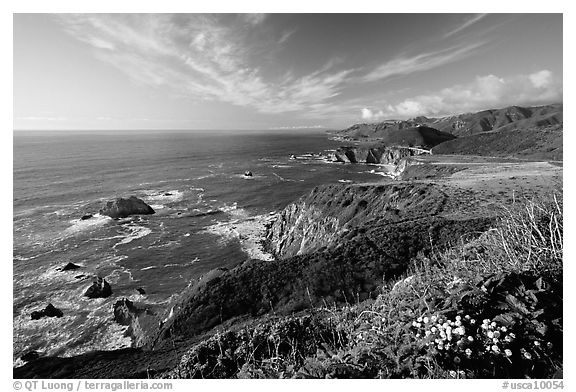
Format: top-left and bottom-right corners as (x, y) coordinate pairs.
(362, 43), (483, 82)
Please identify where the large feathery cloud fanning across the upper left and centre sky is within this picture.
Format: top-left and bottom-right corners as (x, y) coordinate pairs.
(60, 14), (353, 113)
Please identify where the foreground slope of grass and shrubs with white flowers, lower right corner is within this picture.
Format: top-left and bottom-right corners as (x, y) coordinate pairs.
(163, 196), (563, 378)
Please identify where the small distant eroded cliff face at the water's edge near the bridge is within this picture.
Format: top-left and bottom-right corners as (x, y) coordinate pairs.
(334, 147), (428, 165)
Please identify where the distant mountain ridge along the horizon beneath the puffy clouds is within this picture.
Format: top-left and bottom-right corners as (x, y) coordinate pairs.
(334, 103), (563, 140)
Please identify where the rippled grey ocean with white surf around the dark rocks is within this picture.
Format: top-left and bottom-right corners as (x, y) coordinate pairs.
(13, 130), (390, 364)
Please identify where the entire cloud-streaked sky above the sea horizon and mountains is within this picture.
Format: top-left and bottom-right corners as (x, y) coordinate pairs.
(13, 14), (563, 130)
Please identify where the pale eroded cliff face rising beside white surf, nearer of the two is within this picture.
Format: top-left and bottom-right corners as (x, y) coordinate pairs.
(267, 183), (447, 258)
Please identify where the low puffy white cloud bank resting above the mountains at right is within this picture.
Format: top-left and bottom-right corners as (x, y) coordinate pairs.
(361, 70), (562, 119)
